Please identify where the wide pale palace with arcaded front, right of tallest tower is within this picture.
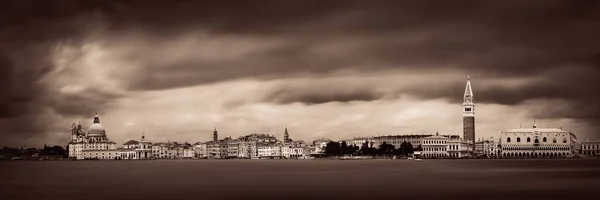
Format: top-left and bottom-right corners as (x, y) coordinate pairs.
(501, 123), (574, 158)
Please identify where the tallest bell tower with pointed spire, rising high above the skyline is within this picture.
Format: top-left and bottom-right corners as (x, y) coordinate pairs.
(463, 76), (475, 150)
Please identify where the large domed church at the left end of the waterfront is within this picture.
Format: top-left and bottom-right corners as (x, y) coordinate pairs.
(68, 114), (119, 159)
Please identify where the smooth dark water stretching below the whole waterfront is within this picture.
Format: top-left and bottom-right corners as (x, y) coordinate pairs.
(0, 159), (600, 200)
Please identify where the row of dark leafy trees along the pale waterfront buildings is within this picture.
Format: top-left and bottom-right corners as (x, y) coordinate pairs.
(325, 141), (422, 156)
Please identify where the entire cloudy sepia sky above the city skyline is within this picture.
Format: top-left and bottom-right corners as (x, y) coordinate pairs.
(0, 0), (600, 146)
